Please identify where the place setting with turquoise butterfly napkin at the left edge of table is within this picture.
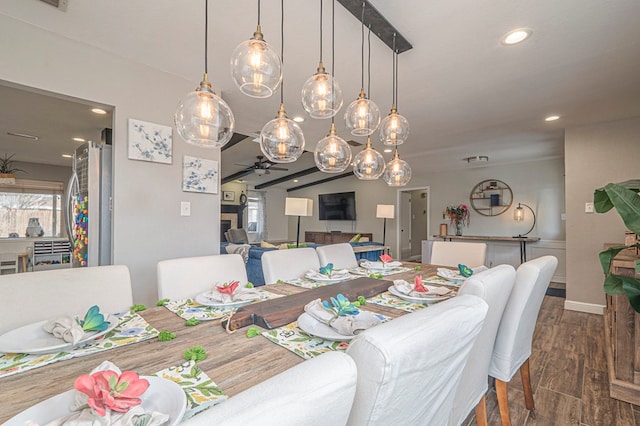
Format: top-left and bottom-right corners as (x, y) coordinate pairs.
(0, 307), (159, 378)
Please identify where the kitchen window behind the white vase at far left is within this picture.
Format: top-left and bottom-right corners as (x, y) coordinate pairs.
(0, 179), (63, 238)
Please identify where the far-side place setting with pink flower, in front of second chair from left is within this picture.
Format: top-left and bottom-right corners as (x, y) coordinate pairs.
(164, 281), (283, 321)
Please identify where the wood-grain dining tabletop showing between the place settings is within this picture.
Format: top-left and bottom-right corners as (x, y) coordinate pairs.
(0, 262), (450, 423)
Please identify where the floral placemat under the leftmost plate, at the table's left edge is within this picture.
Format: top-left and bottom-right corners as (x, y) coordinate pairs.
(0, 311), (158, 377)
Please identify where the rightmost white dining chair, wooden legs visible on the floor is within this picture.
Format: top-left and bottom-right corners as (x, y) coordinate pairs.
(489, 256), (558, 426)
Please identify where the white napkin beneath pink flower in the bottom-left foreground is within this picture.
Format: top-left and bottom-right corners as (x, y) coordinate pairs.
(45, 361), (171, 426)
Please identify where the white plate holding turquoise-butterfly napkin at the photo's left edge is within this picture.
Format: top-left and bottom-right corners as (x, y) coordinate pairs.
(0, 315), (119, 354)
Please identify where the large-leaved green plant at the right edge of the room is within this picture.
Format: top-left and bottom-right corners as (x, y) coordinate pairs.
(593, 179), (640, 313)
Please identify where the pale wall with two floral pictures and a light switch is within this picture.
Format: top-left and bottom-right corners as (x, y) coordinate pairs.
(0, 15), (220, 304)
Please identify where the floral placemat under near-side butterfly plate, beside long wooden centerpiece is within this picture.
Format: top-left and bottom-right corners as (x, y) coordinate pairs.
(262, 313), (391, 359)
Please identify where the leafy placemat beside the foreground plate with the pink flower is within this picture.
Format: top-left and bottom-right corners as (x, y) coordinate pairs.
(154, 361), (228, 420)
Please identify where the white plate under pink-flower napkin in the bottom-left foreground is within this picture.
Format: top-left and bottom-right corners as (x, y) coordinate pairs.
(5, 376), (187, 426)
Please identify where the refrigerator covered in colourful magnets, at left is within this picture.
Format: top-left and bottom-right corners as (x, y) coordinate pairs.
(65, 142), (112, 268)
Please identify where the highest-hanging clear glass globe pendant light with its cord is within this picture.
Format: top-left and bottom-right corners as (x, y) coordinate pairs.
(231, 0), (282, 98)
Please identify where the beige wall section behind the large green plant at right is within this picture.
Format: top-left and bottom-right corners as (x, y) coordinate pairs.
(565, 117), (640, 310)
